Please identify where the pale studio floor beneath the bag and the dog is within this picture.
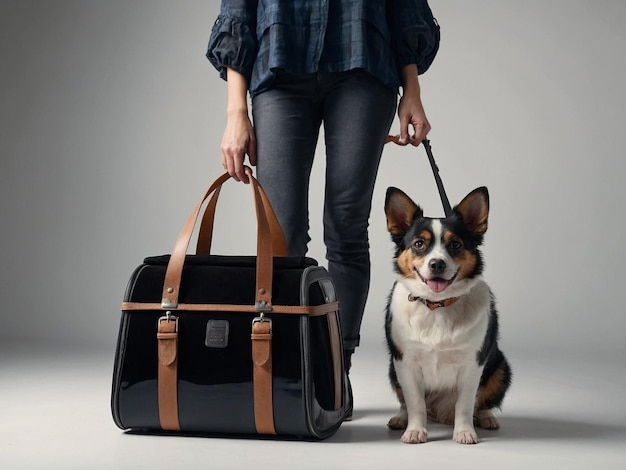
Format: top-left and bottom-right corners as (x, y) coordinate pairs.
(0, 346), (626, 470)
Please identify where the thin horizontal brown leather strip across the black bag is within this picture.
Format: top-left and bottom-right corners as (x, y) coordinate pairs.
(120, 302), (339, 317)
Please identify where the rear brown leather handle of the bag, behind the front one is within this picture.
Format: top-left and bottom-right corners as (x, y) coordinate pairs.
(196, 175), (287, 256)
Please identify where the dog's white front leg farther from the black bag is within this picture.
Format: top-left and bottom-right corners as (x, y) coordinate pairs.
(453, 366), (481, 444)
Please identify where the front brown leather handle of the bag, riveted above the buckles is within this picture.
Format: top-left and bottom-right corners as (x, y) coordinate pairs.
(161, 167), (274, 310)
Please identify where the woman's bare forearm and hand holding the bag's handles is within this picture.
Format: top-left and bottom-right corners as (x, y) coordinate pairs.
(220, 68), (256, 183)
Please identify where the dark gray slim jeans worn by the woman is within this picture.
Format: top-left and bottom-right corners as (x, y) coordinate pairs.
(252, 70), (397, 358)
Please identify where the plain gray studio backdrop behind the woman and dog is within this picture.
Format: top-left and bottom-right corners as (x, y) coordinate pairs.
(0, 0), (626, 359)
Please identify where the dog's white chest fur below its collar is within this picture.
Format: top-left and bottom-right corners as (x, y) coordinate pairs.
(390, 280), (491, 390)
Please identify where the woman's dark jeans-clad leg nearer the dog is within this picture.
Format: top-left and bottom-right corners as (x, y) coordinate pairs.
(316, 71), (397, 366)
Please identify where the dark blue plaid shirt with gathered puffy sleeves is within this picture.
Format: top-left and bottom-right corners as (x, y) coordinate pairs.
(207, 0), (439, 95)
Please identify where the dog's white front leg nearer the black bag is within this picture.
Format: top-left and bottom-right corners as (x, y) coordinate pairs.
(394, 360), (428, 444)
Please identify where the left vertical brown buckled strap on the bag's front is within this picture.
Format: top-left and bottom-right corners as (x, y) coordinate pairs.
(157, 316), (180, 431)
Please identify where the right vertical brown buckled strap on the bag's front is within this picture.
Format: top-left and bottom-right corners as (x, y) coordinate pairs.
(251, 318), (276, 434)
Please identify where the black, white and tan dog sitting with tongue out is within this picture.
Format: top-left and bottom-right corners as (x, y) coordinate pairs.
(385, 187), (512, 444)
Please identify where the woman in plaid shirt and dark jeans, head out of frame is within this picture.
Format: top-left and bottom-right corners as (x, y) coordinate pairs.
(207, 0), (439, 406)
